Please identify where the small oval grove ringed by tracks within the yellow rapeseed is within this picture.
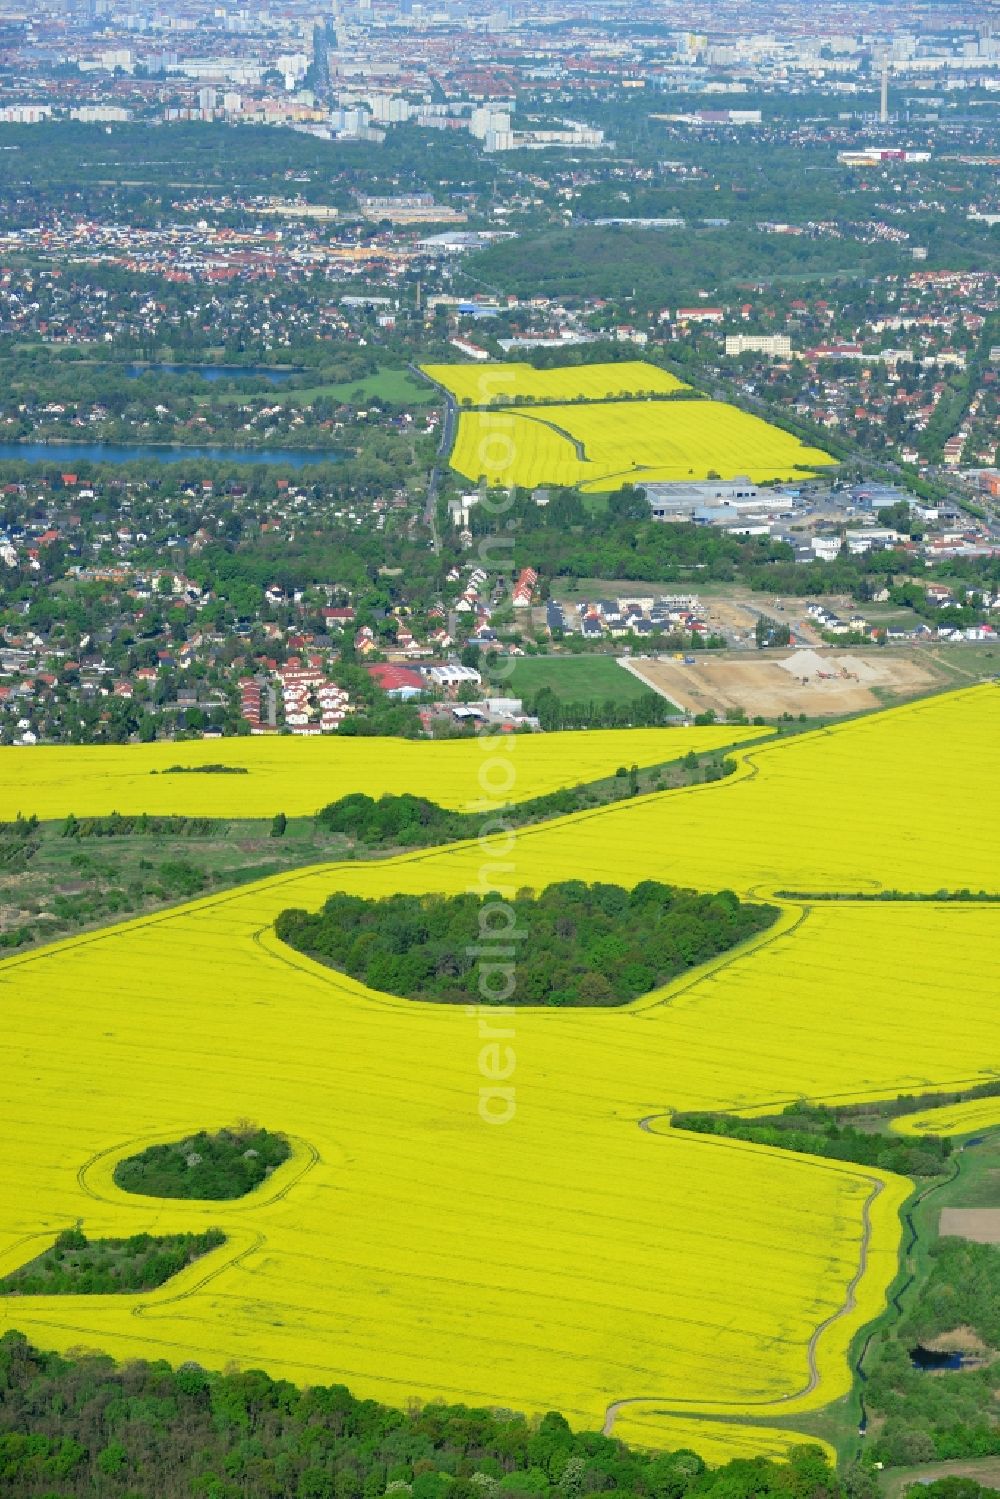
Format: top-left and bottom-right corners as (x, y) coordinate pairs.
(114, 1124), (291, 1202)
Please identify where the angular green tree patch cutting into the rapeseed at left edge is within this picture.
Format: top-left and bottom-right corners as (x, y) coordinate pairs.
(0, 1228), (226, 1301)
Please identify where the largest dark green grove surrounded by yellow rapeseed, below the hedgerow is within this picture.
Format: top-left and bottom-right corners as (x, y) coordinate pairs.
(276, 880), (778, 1004)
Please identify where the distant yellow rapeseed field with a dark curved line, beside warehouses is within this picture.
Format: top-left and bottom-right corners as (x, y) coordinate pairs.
(451, 400), (832, 490)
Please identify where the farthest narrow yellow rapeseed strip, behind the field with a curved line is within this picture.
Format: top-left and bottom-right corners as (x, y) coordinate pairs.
(420, 360), (687, 406)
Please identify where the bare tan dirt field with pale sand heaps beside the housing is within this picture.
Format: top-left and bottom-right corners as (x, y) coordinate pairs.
(633, 649), (945, 718)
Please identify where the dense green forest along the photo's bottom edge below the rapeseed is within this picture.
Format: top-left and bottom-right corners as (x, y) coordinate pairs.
(0, 1333), (863, 1499)
